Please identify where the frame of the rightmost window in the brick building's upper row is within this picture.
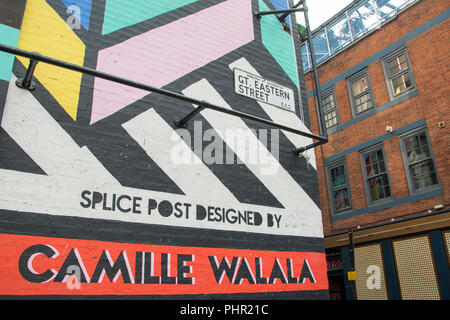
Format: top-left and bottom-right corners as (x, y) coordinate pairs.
(381, 47), (417, 100)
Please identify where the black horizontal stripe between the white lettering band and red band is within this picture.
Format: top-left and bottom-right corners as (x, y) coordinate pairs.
(0, 210), (324, 253)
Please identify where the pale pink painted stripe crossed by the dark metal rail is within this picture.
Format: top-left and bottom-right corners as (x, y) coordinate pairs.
(91, 0), (254, 124)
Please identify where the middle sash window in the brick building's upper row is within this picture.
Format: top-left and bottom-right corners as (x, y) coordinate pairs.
(347, 70), (375, 117)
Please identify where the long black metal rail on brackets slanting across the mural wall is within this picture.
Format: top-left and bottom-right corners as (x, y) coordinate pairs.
(0, 44), (328, 150)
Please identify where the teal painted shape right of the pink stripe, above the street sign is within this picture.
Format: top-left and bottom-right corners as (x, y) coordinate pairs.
(259, 0), (299, 88)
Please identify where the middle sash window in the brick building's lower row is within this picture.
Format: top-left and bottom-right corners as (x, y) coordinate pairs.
(361, 146), (391, 204)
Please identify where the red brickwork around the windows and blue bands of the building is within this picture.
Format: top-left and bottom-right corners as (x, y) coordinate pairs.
(305, 0), (450, 234)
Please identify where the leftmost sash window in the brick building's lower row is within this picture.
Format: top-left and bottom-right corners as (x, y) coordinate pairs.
(327, 161), (352, 214)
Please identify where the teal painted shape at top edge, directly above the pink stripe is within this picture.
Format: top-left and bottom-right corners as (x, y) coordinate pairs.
(102, 0), (198, 35)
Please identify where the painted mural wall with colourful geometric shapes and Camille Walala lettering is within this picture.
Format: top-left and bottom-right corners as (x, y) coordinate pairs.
(0, 0), (328, 299)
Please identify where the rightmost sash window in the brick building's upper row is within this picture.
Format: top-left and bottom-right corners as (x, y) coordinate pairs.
(383, 48), (416, 100)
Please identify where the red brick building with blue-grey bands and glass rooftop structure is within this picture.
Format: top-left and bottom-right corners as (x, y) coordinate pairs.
(302, 0), (450, 299)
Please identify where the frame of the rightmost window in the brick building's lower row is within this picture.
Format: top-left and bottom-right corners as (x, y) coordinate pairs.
(398, 127), (441, 195)
